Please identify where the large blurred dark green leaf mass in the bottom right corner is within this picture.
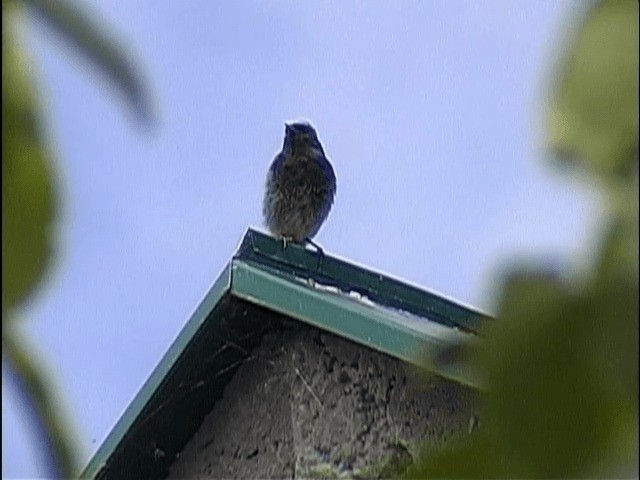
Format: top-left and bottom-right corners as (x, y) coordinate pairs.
(413, 272), (638, 478)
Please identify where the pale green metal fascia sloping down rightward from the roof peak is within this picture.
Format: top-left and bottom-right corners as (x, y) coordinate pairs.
(231, 260), (483, 389)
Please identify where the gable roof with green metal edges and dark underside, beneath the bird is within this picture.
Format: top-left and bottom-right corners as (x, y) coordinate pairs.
(81, 229), (490, 479)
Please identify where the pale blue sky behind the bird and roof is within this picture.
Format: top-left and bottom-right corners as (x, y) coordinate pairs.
(2, 0), (596, 478)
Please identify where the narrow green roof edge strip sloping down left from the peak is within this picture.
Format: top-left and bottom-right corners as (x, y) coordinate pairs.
(80, 264), (231, 478)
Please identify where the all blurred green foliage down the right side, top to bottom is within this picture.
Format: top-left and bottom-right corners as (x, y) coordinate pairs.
(410, 0), (638, 478)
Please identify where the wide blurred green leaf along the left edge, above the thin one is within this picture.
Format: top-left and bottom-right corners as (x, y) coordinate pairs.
(2, 3), (57, 318)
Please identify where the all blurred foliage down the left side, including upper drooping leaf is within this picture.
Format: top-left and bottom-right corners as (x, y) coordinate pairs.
(2, 0), (152, 478)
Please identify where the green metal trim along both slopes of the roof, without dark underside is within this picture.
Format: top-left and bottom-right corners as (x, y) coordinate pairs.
(81, 229), (491, 478)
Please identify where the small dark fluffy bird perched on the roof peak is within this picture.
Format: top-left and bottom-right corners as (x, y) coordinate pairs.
(262, 121), (336, 249)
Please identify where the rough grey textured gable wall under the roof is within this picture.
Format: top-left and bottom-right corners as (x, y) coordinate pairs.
(167, 325), (477, 479)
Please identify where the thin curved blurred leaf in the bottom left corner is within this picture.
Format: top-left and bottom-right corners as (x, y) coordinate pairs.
(2, 326), (78, 478)
